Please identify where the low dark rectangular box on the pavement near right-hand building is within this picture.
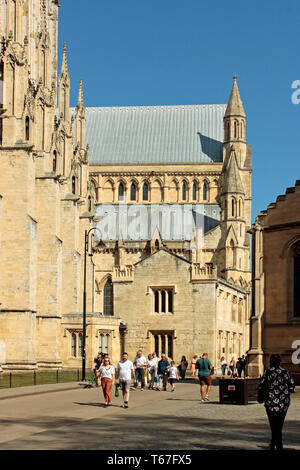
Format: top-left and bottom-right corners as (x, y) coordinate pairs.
(219, 378), (260, 405)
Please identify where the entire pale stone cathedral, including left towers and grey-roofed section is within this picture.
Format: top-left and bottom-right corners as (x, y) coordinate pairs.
(0, 0), (252, 370)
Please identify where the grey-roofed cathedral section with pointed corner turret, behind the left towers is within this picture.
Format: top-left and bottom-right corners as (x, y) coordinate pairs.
(86, 77), (251, 366)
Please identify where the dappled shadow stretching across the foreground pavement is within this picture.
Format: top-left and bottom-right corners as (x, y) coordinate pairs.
(0, 412), (300, 450)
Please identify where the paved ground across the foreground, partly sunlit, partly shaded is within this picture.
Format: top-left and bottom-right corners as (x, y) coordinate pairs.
(0, 382), (300, 450)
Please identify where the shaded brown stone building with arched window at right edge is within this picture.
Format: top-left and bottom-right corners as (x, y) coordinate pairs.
(248, 181), (300, 380)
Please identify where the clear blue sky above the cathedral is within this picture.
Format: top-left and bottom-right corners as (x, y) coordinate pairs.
(59, 0), (300, 219)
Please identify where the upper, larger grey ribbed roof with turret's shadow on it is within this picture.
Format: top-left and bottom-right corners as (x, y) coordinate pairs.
(86, 104), (226, 165)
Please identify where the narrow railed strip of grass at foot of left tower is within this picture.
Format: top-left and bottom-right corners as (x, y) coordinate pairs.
(0, 369), (92, 389)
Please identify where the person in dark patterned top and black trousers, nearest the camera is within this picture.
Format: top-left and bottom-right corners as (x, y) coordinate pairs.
(258, 354), (295, 451)
